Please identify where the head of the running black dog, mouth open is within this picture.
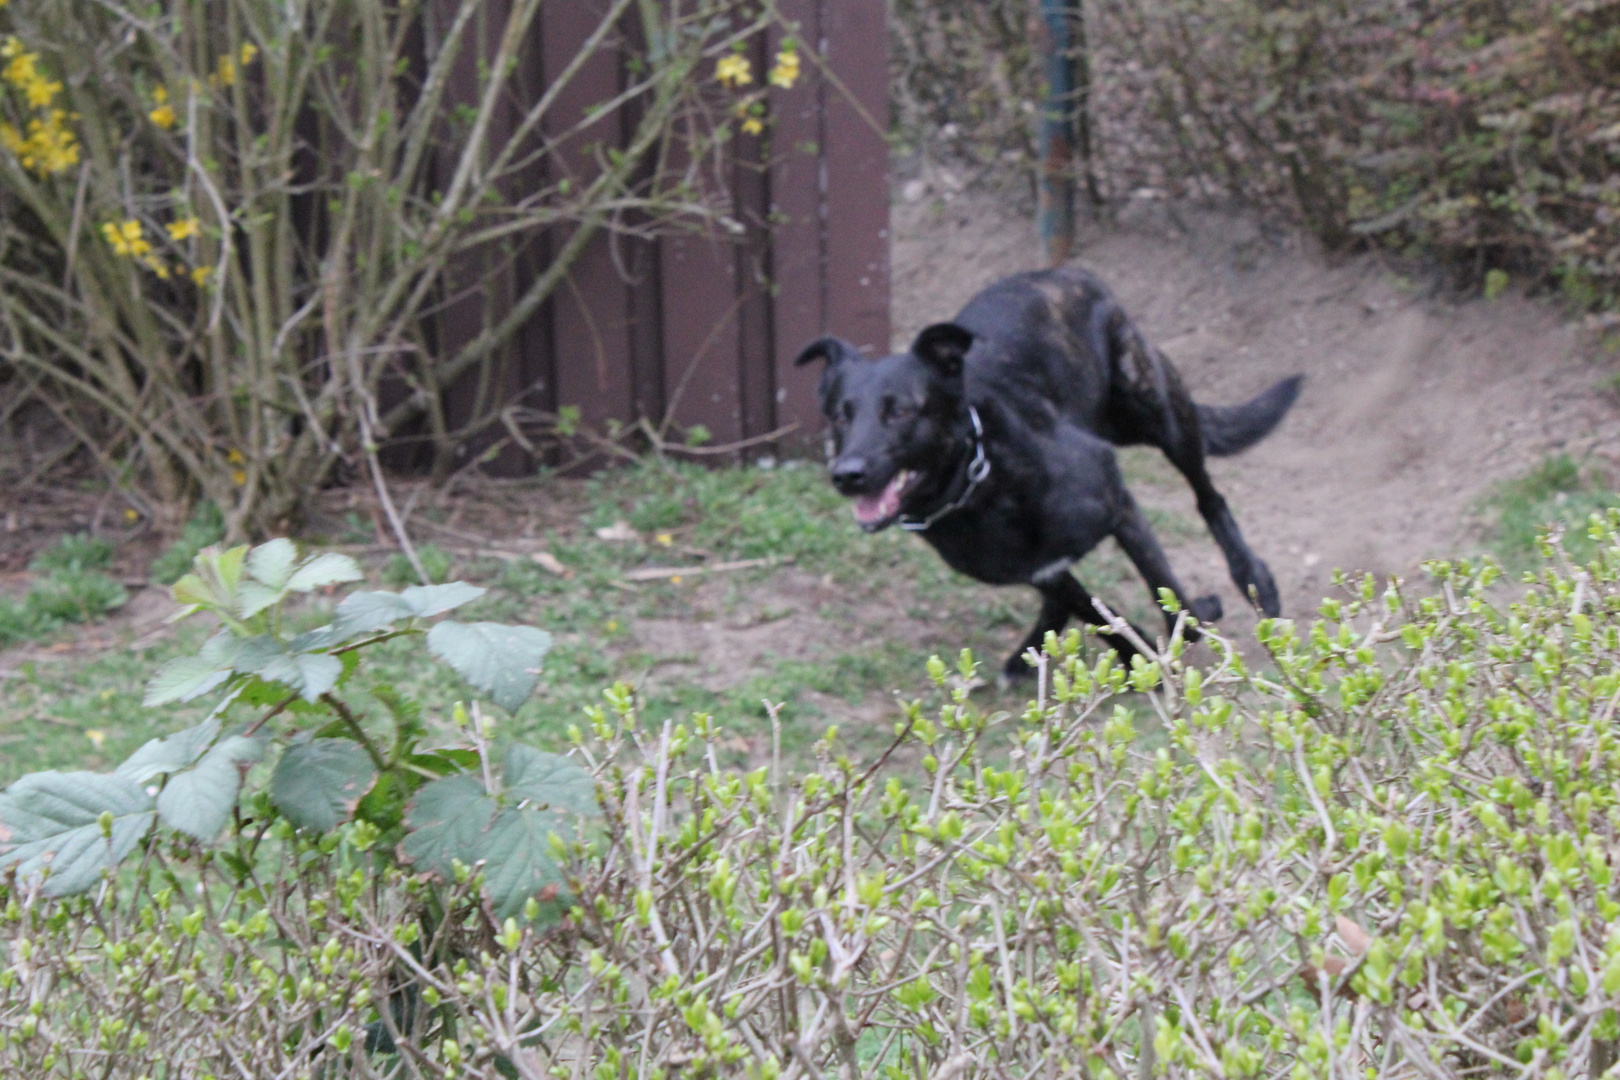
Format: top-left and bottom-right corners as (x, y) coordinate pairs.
(794, 322), (974, 533)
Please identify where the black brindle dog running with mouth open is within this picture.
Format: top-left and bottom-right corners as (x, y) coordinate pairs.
(795, 267), (1301, 677)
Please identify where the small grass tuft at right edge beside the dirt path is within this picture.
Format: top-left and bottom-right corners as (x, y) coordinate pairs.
(1482, 453), (1620, 570)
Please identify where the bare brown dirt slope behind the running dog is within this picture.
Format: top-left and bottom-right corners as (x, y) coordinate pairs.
(894, 196), (1620, 633)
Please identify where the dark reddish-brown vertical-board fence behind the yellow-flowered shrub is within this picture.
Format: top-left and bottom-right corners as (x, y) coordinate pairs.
(436, 0), (889, 473)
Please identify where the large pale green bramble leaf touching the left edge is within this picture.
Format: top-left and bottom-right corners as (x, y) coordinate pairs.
(0, 772), (154, 897)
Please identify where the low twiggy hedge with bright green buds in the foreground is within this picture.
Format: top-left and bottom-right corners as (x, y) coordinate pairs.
(9, 512), (1620, 1080)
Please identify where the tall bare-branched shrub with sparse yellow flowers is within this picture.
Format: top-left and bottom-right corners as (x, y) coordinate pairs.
(0, 0), (799, 538)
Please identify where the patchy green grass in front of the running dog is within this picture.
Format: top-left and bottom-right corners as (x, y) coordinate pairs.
(0, 461), (1185, 782)
